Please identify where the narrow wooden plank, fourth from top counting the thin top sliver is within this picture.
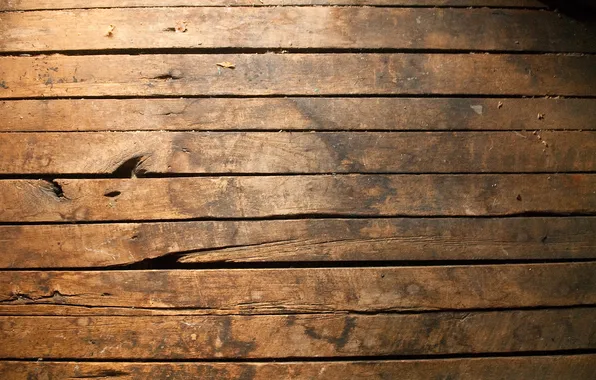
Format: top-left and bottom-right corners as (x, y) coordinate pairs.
(0, 97), (596, 132)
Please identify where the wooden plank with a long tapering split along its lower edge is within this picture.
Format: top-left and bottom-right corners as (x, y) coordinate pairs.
(0, 217), (596, 268)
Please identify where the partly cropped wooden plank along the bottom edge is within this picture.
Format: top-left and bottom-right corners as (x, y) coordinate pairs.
(0, 355), (596, 380)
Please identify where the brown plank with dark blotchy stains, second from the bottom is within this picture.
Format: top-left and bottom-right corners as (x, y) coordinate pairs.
(0, 308), (596, 360)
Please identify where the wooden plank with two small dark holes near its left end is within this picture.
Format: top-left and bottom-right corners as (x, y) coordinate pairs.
(0, 174), (596, 222)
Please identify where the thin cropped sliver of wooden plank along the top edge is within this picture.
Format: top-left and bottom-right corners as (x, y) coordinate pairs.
(0, 0), (546, 11)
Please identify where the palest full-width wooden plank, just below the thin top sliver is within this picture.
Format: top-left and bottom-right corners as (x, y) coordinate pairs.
(0, 7), (584, 53)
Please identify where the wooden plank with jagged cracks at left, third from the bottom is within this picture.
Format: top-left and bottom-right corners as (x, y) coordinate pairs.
(0, 263), (596, 315)
